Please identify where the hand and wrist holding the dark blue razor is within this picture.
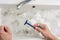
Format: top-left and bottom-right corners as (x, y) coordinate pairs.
(34, 24), (57, 40)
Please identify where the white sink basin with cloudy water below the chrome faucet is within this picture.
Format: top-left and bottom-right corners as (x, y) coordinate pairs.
(1, 5), (60, 40)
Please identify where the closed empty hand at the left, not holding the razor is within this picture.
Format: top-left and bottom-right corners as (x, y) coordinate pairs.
(0, 26), (12, 40)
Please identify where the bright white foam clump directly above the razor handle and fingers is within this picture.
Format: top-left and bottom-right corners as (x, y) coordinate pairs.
(30, 12), (44, 25)
